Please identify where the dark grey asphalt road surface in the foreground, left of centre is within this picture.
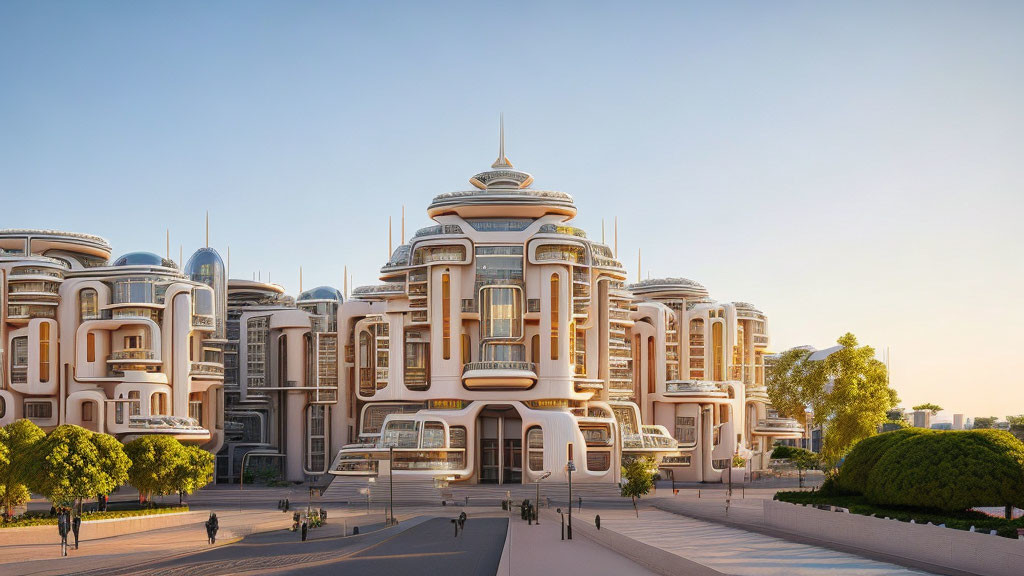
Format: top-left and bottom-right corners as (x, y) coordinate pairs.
(66, 518), (508, 576)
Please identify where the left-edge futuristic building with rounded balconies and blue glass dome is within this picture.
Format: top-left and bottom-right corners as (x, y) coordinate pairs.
(0, 230), (224, 451)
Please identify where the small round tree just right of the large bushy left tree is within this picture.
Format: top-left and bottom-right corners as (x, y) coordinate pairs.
(125, 435), (187, 501)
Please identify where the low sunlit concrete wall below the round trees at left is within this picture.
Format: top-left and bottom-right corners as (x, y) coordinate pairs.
(0, 511), (203, 546)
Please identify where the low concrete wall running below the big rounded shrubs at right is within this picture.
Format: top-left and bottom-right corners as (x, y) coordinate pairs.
(764, 500), (1024, 576)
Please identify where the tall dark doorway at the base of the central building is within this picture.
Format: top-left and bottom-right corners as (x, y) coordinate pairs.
(476, 405), (522, 484)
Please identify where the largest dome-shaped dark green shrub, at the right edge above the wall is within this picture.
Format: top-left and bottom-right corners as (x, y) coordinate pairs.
(864, 429), (1024, 511)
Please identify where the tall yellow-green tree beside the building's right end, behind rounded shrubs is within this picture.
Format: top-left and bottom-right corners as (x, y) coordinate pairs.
(768, 333), (899, 467)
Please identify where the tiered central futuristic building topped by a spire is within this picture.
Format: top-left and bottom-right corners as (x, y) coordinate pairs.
(331, 134), (676, 484)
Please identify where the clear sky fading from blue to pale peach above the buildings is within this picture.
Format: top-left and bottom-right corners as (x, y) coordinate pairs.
(0, 1), (1024, 417)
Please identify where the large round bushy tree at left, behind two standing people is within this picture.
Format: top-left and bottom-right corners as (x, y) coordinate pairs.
(34, 424), (125, 504)
